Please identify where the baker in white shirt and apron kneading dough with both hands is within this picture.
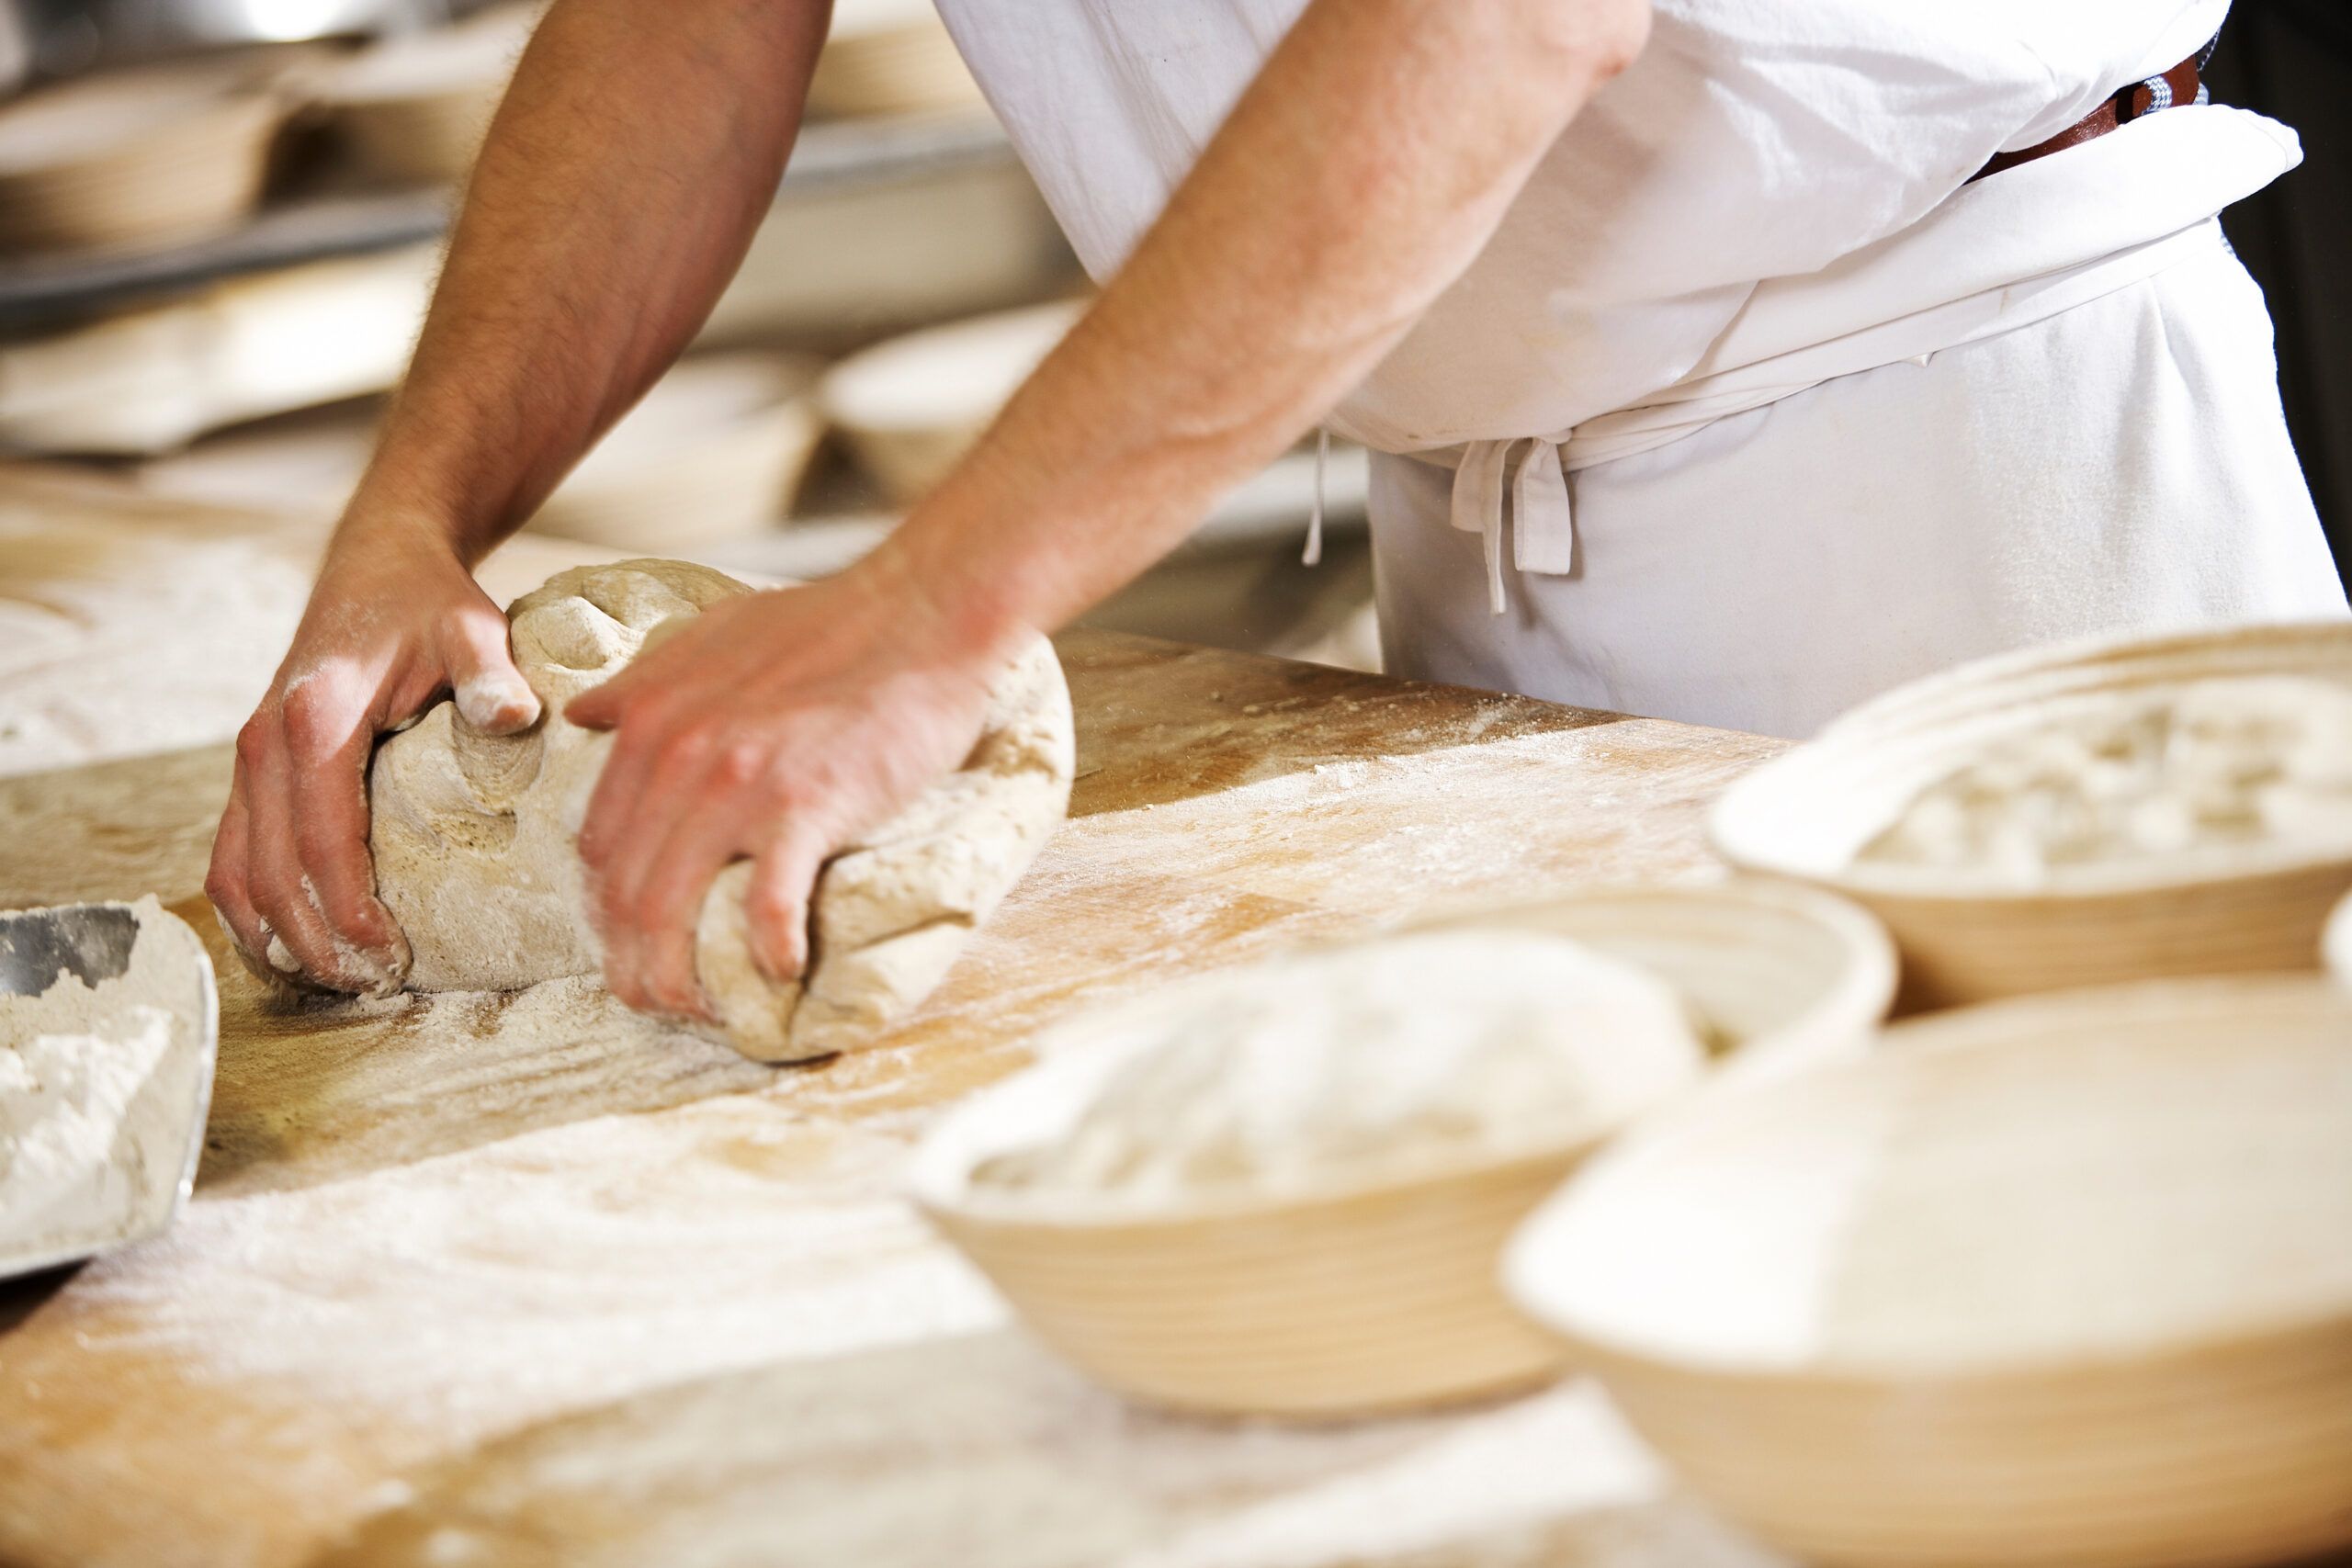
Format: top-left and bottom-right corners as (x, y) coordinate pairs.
(209, 0), (2345, 1018)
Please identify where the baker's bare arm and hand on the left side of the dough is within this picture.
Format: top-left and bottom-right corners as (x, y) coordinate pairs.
(207, 0), (831, 989)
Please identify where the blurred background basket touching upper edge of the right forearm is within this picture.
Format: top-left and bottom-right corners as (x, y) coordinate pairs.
(819, 301), (1084, 505)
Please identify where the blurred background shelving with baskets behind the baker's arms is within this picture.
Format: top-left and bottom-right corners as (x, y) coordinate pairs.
(0, 0), (1378, 668)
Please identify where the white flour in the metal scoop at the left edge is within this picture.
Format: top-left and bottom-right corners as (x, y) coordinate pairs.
(0, 898), (188, 1253)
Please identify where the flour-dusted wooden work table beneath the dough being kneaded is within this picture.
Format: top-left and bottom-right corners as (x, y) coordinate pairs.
(0, 632), (1773, 1568)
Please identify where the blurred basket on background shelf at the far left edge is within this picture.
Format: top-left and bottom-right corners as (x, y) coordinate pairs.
(0, 54), (291, 252)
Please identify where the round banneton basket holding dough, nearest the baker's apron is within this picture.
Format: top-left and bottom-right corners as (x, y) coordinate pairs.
(1708, 623), (2352, 1009)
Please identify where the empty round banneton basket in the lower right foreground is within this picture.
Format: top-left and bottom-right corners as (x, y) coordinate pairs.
(1505, 976), (2352, 1568)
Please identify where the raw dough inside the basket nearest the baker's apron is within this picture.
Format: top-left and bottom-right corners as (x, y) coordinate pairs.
(1860, 674), (2352, 886)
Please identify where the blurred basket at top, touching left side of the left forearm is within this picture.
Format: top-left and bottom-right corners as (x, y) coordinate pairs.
(311, 5), (537, 184)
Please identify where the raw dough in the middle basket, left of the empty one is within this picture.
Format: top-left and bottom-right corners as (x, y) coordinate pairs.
(974, 931), (1705, 1203)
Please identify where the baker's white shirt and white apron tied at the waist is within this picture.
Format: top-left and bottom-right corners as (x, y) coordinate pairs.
(941, 0), (2345, 733)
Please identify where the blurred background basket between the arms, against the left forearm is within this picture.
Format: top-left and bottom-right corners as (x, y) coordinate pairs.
(529, 353), (823, 552)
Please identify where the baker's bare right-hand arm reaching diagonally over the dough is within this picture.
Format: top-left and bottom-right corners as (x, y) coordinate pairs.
(571, 0), (1649, 1013)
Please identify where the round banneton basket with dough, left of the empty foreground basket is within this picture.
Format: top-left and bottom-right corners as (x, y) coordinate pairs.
(912, 886), (1894, 1420)
